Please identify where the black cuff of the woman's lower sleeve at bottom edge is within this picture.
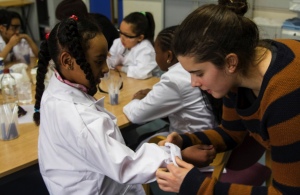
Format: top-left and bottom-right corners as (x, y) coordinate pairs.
(179, 167), (205, 194)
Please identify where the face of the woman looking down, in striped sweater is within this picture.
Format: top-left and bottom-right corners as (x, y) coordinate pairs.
(178, 56), (236, 98)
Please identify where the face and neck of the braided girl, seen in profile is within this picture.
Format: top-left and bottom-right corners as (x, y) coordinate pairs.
(68, 34), (109, 88)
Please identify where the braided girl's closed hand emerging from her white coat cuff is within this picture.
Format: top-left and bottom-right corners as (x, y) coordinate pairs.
(181, 144), (216, 167)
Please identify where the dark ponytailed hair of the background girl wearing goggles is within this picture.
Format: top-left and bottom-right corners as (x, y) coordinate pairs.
(123, 12), (155, 44)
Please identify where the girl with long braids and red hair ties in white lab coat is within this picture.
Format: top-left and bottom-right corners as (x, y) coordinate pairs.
(34, 15), (170, 195)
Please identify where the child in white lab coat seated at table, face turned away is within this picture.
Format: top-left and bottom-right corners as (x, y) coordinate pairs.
(123, 26), (218, 145)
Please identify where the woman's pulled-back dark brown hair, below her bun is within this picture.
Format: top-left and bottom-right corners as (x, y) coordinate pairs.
(173, 4), (259, 75)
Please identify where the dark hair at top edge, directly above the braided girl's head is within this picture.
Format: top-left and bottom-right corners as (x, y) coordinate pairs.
(55, 0), (88, 20)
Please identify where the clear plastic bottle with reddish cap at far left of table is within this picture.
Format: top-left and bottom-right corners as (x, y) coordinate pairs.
(1, 68), (18, 103)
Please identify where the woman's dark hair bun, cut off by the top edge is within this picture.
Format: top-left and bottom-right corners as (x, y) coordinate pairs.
(218, 0), (248, 16)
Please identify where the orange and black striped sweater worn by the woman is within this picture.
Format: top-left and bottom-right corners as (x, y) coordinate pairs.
(180, 40), (300, 195)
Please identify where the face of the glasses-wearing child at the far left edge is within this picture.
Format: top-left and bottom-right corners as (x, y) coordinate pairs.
(0, 18), (21, 43)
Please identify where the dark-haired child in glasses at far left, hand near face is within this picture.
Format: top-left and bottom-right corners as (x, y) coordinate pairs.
(0, 9), (38, 63)
